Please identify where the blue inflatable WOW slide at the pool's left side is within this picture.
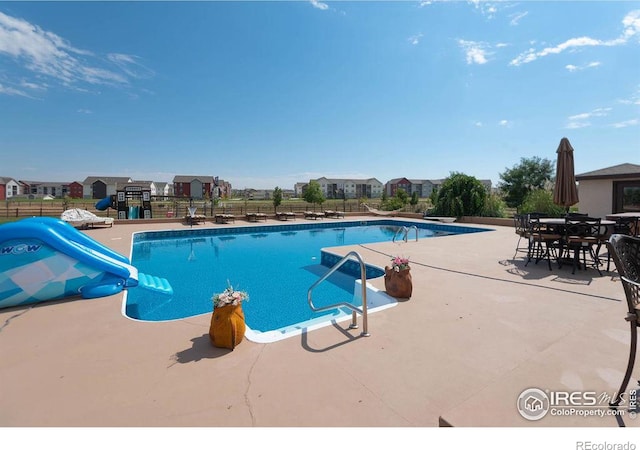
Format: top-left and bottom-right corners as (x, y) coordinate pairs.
(0, 217), (173, 308)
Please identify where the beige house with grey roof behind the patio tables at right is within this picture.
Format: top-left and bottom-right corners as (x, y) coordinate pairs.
(576, 163), (640, 217)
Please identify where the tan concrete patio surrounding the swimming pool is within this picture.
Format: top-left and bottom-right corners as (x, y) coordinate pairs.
(0, 217), (640, 427)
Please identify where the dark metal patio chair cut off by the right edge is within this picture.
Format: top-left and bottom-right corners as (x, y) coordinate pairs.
(607, 234), (640, 407)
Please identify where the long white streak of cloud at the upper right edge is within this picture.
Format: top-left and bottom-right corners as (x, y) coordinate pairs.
(509, 10), (640, 66)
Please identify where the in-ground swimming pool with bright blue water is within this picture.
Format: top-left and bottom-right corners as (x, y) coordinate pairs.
(123, 219), (486, 342)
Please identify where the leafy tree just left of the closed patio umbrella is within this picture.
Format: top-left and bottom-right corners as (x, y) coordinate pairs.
(498, 156), (554, 207)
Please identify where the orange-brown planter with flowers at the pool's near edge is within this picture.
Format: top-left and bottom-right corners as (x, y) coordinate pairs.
(209, 284), (249, 350)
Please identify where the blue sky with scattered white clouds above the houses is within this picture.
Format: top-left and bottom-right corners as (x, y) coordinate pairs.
(0, 0), (640, 189)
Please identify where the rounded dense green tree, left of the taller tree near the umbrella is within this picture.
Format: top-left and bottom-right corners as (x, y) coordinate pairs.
(434, 172), (487, 217)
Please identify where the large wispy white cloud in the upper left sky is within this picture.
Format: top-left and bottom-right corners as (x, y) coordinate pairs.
(0, 12), (153, 93)
